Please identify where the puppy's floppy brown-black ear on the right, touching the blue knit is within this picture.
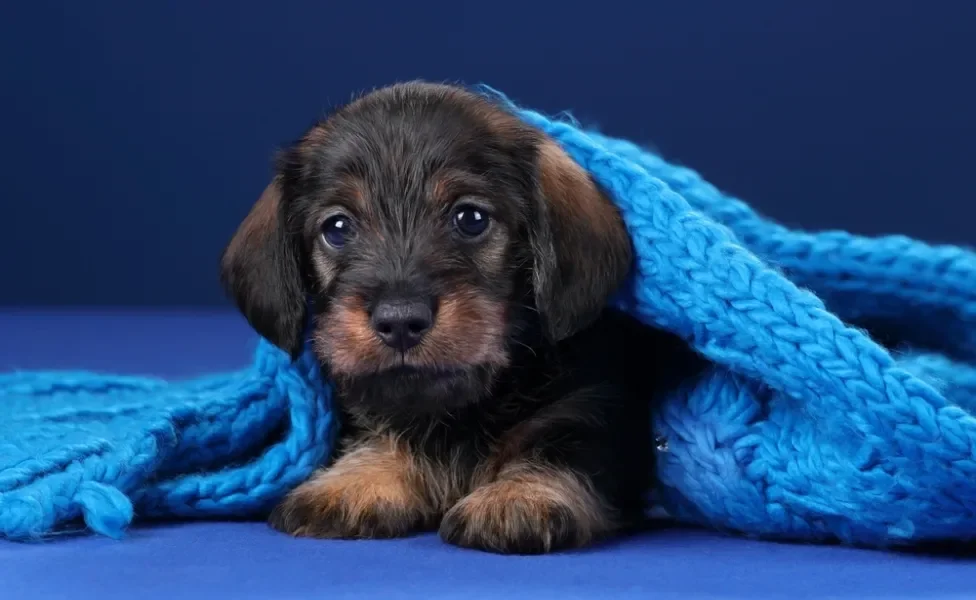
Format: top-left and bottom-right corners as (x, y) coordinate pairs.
(532, 138), (633, 341)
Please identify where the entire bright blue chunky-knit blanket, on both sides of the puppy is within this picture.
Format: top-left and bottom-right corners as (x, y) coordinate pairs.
(0, 90), (976, 547)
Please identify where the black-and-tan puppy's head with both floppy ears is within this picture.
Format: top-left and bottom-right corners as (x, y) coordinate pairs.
(222, 83), (631, 420)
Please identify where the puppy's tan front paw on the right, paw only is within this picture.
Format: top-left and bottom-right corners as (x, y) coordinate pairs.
(440, 472), (610, 554)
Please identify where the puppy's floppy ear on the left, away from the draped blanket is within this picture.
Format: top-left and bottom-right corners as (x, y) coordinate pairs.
(220, 178), (307, 358)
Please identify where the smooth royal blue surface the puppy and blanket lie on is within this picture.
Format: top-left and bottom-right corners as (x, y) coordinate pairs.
(0, 311), (976, 600)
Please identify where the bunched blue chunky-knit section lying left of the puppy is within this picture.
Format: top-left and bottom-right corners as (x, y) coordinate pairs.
(0, 340), (336, 540)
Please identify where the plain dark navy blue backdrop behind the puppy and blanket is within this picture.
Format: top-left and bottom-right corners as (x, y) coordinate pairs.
(0, 0), (976, 305)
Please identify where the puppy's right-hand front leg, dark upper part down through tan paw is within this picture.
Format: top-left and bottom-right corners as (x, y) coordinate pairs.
(440, 386), (646, 554)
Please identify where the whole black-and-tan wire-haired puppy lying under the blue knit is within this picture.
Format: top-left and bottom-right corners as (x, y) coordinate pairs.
(222, 82), (684, 553)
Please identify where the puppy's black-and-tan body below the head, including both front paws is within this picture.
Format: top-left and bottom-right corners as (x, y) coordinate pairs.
(273, 311), (670, 553)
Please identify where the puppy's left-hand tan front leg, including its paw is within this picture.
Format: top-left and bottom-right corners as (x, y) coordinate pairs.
(270, 435), (435, 538)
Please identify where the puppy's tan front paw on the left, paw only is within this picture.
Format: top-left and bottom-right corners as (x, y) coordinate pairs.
(269, 471), (430, 539)
